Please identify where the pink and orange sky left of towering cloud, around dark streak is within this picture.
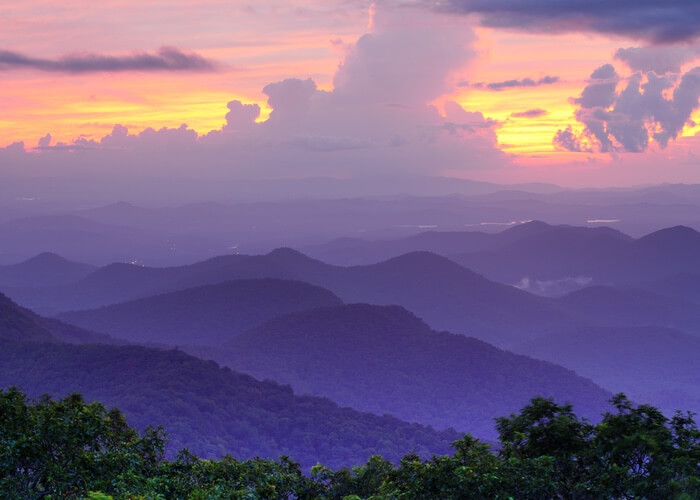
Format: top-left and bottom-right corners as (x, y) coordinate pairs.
(0, 0), (360, 147)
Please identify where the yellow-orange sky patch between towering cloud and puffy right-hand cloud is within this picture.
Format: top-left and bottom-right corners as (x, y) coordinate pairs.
(446, 28), (617, 156)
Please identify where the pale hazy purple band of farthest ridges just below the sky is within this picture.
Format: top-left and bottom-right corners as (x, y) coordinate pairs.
(0, 188), (700, 266)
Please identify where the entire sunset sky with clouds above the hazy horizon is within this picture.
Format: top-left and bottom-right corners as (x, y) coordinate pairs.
(0, 0), (700, 187)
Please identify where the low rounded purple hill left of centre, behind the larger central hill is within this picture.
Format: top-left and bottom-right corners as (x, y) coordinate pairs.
(58, 279), (342, 345)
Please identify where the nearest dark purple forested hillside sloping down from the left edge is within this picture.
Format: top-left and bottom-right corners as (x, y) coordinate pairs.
(0, 292), (459, 468)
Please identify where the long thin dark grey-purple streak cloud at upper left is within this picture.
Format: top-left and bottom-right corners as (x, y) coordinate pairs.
(0, 47), (216, 73)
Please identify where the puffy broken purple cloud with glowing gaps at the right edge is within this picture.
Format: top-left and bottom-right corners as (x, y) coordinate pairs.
(554, 64), (700, 152)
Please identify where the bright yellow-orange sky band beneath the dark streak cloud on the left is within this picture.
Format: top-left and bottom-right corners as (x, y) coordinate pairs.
(0, 43), (338, 147)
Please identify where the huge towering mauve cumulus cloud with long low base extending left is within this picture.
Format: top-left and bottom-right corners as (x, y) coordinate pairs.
(0, 3), (509, 179)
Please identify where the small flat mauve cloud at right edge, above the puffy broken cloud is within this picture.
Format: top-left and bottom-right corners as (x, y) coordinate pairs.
(615, 45), (700, 75)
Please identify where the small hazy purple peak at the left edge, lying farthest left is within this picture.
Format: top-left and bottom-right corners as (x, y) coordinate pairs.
(0, 252), (97, 287)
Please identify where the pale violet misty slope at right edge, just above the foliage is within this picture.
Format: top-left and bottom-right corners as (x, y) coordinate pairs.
(517, 326), (700, 412)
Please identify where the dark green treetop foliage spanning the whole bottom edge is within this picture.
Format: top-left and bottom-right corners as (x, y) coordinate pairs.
(0, 389), (700, 500)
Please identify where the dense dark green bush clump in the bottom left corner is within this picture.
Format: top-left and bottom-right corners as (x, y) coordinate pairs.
(0, 388), (164, 498)
